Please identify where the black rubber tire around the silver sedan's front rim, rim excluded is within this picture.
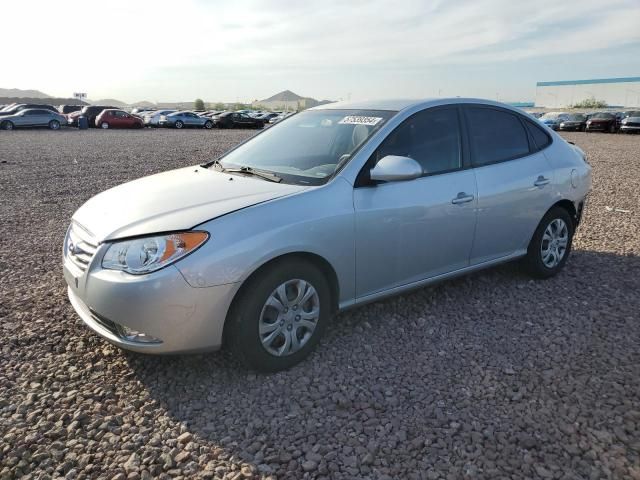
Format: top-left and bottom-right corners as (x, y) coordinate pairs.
(225, 259), (333, 372)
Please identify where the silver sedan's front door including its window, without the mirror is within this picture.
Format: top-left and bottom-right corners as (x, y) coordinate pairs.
(354, 107), (477, 298)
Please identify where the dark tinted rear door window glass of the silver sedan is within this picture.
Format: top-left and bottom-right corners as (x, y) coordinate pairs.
(466, 107), (529, 167)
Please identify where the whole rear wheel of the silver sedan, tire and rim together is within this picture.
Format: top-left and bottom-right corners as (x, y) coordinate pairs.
(524, 207), (574, 278)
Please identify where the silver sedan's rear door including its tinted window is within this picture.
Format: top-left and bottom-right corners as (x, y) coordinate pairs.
(464, 105), (553, 265)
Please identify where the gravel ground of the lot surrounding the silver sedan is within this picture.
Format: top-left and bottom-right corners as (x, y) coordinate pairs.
(0, 130), (640, 480)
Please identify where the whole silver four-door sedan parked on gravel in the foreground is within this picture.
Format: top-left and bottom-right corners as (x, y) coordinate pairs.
(63, 99), (591, 371)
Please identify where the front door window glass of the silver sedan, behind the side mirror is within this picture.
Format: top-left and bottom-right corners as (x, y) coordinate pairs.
(374, 108), (462, 175)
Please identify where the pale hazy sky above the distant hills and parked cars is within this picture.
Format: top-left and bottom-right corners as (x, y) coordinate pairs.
(5, 0), (640, 102)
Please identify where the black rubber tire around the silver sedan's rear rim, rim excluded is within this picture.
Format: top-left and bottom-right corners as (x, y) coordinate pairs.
(523, 207), (575, 278)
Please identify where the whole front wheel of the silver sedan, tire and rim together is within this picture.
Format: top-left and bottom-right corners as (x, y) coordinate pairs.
(225, 261), (332, 372)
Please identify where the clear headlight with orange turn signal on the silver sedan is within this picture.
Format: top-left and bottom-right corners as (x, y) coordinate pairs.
(102, 232), (209, 275)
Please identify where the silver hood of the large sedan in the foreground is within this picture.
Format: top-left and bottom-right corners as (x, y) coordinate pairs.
(73, 166), (309, 242)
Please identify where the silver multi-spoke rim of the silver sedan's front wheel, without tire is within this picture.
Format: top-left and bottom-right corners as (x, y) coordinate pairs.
(258, 279), (320, 357)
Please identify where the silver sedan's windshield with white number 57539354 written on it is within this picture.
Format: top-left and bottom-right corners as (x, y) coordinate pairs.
(214, 110), (396, 185)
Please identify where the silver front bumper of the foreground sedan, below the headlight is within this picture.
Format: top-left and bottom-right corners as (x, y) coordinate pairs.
(64, 256), (238, 354)
